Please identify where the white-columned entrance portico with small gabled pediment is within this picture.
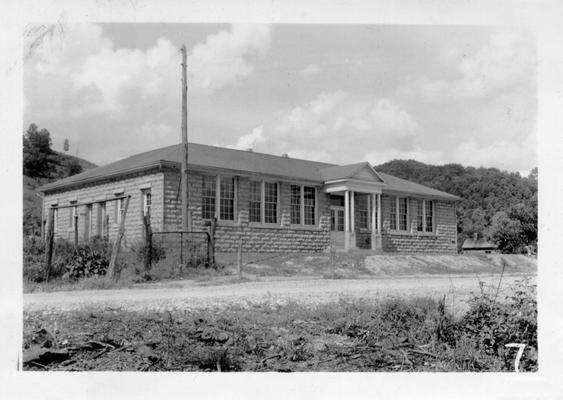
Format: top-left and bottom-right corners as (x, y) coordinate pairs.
(323, 163), (385, 251)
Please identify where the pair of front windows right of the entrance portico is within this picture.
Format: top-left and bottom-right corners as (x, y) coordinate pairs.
(389, 196), (434, 233)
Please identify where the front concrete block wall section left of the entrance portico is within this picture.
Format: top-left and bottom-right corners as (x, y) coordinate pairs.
(164, 170), (330, 252)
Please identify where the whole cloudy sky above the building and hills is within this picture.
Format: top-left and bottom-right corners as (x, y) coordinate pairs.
(23, 23), (538, 176)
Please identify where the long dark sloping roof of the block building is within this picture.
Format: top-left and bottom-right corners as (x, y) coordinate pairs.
(37, 143), (460, 200)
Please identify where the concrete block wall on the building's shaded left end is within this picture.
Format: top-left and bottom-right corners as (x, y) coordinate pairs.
(43, 170), (164, 247)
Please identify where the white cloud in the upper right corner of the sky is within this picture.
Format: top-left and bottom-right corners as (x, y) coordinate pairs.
(398, 32), (535, 103)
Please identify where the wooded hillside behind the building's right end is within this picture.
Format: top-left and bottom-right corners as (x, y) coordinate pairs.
(374, 160), (538, 252)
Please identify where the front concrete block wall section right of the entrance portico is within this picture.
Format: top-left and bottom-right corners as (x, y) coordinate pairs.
(381, 195), (457, 253)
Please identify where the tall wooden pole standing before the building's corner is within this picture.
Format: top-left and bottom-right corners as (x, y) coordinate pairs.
(181, 45), (191, 231)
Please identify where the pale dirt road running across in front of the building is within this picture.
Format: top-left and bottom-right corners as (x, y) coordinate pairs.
(23, 274), (536, 313)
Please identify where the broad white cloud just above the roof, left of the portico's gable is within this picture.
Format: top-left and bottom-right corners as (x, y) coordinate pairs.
(231, 91), (420, 163)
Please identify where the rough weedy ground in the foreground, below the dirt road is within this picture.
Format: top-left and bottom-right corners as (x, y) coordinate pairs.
(24, 282), (537, 372)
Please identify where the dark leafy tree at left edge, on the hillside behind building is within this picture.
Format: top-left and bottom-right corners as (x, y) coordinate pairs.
(23, 124), (53, 177)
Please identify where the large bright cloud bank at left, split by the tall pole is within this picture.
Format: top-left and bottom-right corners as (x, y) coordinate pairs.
(24, 24), (271, 164)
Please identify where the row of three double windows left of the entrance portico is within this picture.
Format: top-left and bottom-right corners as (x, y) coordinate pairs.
(201, 176), (317, 226)
